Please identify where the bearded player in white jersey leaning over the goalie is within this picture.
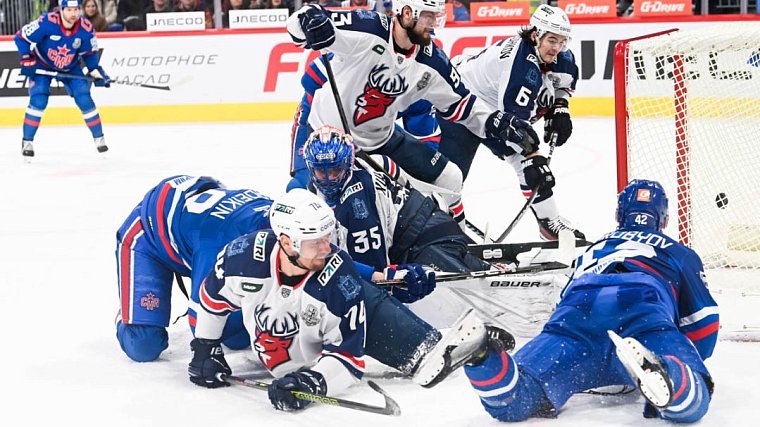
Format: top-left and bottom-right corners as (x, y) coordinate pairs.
(287, 0), (552, 219)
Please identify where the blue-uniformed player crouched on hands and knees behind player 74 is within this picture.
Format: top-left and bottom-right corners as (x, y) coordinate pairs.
(116, 175), (272, 362)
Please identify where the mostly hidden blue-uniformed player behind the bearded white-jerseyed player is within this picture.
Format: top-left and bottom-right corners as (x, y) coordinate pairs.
(287, 53), (441, 191)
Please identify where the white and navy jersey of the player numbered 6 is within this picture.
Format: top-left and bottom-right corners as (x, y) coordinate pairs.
(452, 36), (578, 122)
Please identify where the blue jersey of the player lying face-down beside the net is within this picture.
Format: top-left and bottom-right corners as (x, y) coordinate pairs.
(562, 229), (719, 359)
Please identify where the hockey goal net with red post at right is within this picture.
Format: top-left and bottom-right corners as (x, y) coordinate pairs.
(615, 22), (760, 340)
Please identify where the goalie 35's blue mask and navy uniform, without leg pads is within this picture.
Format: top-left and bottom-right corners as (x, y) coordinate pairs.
(304, 126), (491, 280)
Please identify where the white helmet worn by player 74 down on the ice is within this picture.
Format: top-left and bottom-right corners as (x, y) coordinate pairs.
(269, 188), (338, 252)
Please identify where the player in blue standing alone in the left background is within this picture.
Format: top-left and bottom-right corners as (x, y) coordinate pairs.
(14, 0), (111, 161)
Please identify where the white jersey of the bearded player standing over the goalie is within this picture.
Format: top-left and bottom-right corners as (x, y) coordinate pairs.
(287, 6), (493, 151)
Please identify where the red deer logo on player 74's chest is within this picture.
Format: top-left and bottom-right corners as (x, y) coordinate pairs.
(253, 304), (299, 371)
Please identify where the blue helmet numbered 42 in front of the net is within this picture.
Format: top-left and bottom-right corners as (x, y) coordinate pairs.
(616, 179), (668, 231)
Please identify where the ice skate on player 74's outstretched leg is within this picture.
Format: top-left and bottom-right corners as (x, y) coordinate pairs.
(412, 308), (488, 388)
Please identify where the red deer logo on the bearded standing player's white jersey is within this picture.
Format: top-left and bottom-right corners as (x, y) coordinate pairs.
(354, 64), (409, 126)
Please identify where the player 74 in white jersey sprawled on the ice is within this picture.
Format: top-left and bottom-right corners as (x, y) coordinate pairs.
(189, 189), (510, 409)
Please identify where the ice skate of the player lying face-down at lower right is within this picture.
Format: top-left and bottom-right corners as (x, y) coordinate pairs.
(607, 331), (673, 408)
